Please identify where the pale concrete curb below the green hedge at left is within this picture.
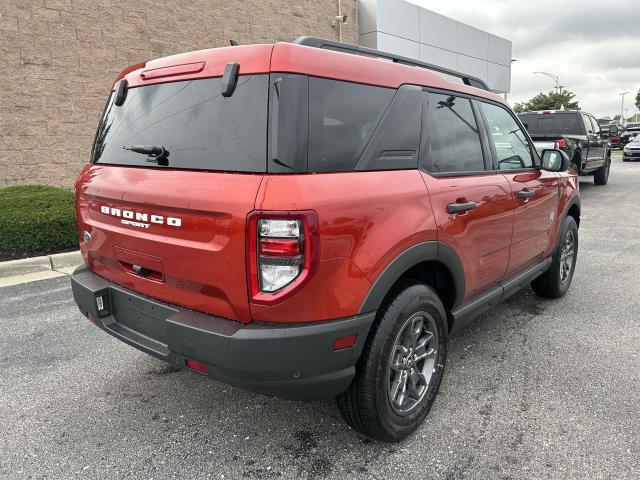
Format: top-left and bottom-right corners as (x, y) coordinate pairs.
(0, 250), (84, 287)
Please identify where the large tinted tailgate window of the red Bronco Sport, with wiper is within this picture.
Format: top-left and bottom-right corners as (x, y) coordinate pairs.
(92, 75), (269, 172)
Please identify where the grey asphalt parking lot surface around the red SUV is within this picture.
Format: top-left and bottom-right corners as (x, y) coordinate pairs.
(0, 156), (640, 479)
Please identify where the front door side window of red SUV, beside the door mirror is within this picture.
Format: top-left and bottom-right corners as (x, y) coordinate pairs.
(479, 102), (533, 170)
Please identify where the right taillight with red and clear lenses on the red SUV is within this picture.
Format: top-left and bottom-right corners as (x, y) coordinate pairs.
(247, 210), (319, 305)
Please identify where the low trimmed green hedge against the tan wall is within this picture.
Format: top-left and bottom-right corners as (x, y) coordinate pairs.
(0, 185), (78, 260)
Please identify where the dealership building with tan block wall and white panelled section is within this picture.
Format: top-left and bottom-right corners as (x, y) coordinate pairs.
(0, 0), (511, 188)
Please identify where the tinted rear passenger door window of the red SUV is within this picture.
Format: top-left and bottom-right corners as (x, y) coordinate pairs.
(423, 93), (485, 173)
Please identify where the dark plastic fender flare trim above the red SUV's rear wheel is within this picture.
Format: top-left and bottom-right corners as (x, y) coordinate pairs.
(359, 241), (465, 313)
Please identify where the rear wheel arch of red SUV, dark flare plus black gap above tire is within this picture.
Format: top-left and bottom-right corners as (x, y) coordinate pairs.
(360, 241), (465, 326)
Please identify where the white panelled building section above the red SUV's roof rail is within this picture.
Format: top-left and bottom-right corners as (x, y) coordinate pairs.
(358, 0), (511, 93)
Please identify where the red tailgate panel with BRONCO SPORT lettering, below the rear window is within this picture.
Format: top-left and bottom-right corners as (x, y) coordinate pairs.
(78, 165), (262, 322)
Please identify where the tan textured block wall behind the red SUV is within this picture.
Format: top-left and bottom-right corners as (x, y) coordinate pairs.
(0, 0), (358, 188)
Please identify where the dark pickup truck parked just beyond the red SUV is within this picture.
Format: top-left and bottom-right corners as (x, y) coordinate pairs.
(518, 110), (611, 185)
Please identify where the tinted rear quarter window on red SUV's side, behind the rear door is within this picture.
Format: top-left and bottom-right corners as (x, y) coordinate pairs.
(309, 77), (395, 172)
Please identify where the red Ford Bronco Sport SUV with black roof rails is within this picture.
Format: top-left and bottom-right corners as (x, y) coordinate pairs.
(72, 37), (580, 441)
